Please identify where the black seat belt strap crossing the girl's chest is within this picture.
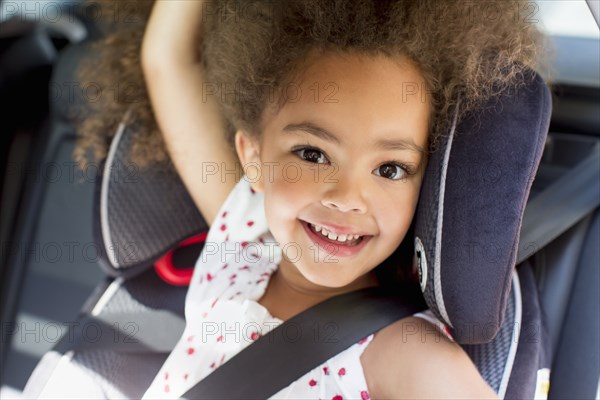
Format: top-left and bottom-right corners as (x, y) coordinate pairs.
(182, 288), (420, 399)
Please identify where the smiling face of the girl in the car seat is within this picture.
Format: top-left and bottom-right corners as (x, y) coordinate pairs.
(236, 54), (430, 288)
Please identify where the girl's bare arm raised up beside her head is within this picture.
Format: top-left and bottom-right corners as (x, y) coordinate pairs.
(141, 0), (241, 224)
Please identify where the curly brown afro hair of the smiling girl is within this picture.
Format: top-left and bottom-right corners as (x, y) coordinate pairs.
(74, 0), (543, 166)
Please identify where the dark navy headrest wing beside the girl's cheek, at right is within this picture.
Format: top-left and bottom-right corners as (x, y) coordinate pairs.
(415, 71), (552, 344)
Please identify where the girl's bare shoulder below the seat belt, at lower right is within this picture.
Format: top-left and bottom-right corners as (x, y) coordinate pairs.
(361, 317), (497, 399)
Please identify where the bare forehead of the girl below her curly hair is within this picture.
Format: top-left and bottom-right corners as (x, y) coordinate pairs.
(263, 53), (430, 146)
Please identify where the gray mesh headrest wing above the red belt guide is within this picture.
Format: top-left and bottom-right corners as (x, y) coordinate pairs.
(94, 123), (207, 278)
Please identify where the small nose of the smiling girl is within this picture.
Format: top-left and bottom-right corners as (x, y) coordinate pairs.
(321, 173), (367, 214)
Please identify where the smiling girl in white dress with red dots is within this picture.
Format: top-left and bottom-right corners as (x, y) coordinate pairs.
(72, 0), (537, 399)
